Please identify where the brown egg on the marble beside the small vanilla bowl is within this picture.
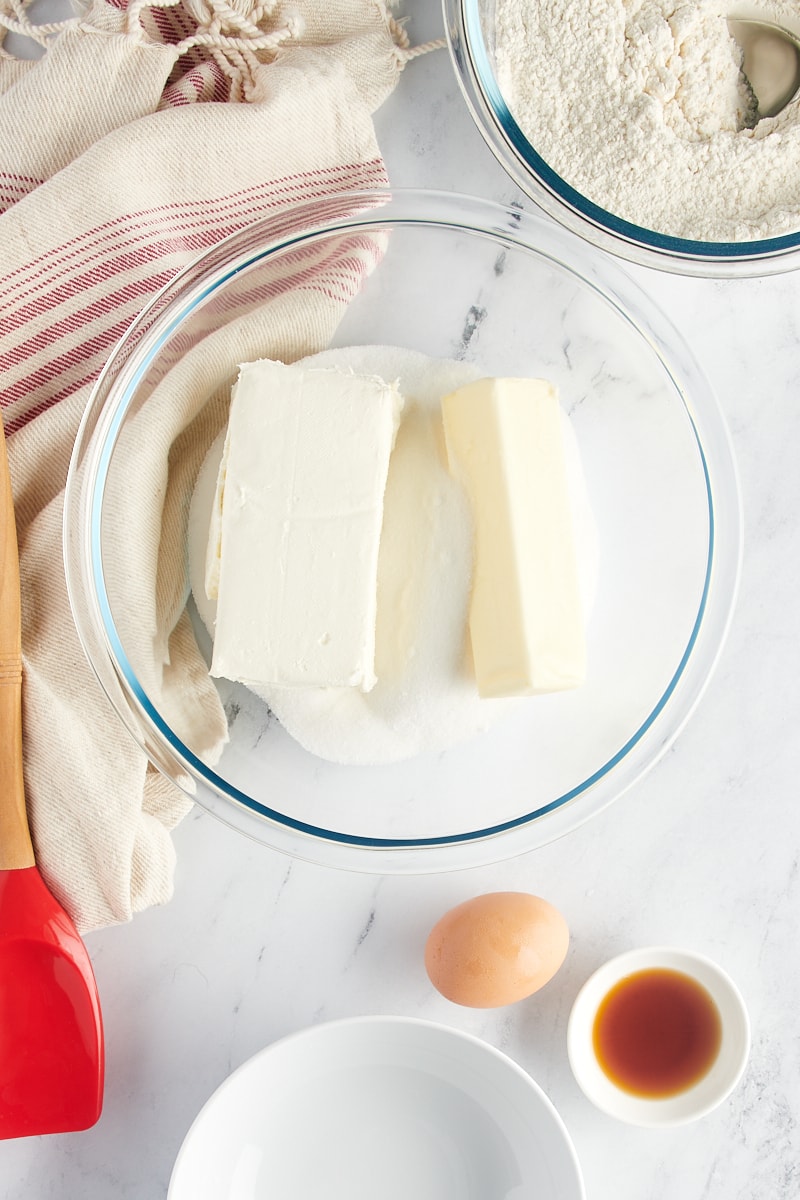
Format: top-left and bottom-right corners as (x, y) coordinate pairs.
(425, 892), (570, 1008)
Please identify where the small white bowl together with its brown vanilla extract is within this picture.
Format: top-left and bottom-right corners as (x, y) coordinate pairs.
(567, 947), (750, 1126)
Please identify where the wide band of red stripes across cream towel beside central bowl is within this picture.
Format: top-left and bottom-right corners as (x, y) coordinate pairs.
(0, 160), (386, 432)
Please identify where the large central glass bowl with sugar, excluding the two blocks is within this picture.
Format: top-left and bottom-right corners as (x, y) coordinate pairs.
(65, 190), (741, 872)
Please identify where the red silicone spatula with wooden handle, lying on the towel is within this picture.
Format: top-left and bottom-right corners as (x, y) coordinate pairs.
(0, 412), (104, 1138)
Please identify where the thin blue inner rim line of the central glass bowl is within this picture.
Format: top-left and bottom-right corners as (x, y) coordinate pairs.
(88, 204), (715, 850)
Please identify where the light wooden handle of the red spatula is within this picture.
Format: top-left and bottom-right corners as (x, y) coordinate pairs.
(0, 431), (34, 870)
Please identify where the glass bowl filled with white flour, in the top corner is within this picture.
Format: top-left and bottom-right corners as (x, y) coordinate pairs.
(444, 0), (800, 276)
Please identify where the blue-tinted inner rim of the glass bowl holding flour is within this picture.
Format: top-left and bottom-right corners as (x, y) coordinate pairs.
(462, 0), (800, 260)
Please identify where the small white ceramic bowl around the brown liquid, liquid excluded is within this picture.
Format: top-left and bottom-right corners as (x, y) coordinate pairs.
(567, 946), (750, 1127)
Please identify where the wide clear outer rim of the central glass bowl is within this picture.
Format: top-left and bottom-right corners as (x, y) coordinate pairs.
(64, 188), (742, 874)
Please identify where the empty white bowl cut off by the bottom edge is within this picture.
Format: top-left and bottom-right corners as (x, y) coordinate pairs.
(169, 1016), (584, 1200)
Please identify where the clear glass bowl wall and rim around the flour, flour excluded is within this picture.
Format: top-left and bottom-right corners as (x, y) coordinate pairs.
(443, 0), (800, 277)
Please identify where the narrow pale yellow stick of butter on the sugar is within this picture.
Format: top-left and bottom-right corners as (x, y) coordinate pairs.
(441, 379), (587, 696)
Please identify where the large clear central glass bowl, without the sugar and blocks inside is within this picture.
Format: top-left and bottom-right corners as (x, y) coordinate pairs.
(65, 191), (741, 872)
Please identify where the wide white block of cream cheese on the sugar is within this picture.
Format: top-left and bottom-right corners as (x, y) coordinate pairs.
(206, 360), (402, 691)
